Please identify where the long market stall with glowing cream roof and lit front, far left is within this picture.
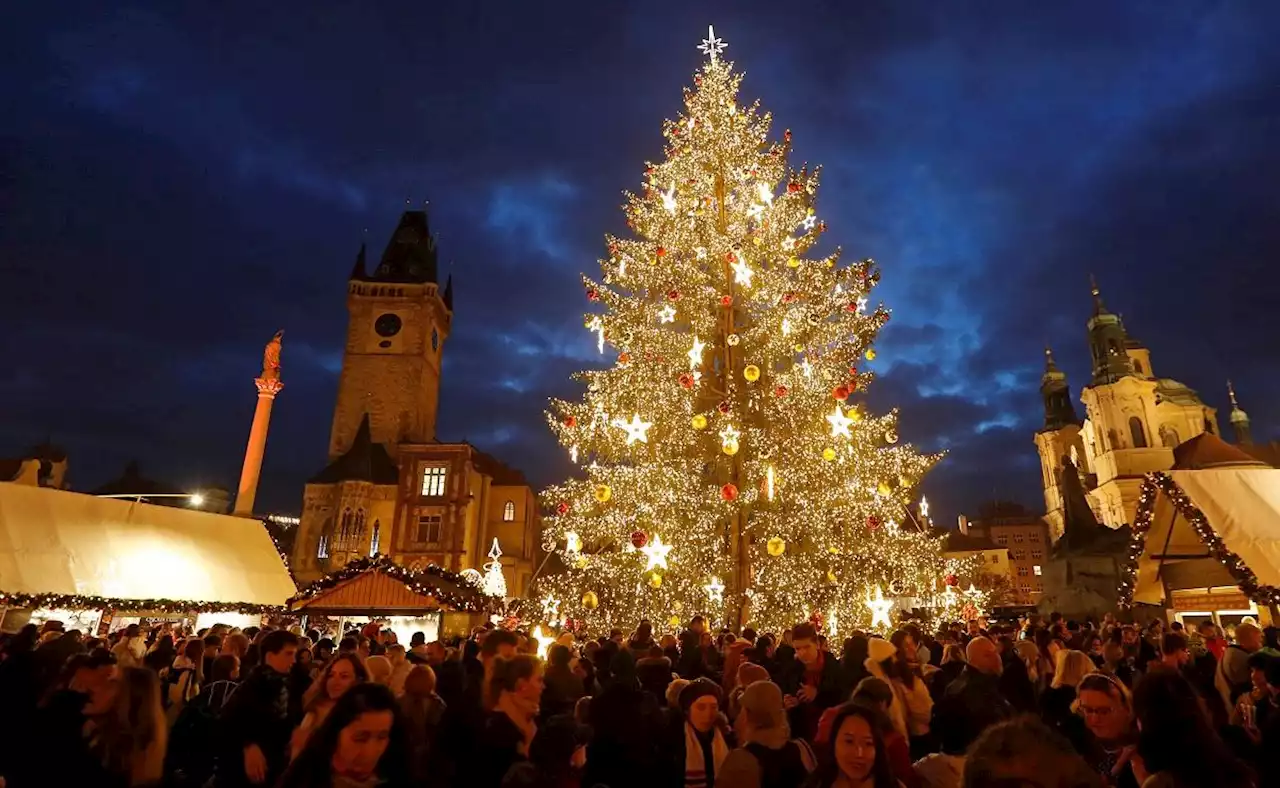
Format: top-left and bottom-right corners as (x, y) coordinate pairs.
(0, 482), (297, 633)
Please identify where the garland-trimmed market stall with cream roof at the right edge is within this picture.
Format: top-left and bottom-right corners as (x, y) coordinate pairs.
(1121, 434), (1280, 627)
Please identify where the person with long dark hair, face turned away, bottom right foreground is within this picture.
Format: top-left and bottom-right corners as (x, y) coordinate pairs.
(1132, 670), (1257, 788)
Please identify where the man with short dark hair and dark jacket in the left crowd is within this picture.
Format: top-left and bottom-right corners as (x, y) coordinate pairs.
(218, 629), (298, 788)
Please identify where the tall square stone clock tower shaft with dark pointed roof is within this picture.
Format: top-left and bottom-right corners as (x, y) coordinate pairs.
(329, 211), (453, 461)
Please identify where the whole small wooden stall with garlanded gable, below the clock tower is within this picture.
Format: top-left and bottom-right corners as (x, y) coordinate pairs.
(289, 555), (500, 642)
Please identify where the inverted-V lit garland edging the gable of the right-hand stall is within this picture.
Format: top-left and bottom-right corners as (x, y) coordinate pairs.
(1120, 472), (1280, 608)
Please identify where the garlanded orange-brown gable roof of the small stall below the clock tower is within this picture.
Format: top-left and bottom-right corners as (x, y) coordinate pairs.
(289, 555), (493, 615)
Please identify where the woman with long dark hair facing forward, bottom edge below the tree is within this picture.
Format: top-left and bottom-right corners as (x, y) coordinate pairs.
(804, 704), (899, 788)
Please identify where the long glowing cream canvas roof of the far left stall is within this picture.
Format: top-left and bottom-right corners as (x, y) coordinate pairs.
(0, 482), (297, 609)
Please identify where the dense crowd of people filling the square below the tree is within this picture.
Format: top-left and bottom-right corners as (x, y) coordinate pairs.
(0, 614), (1280, 788)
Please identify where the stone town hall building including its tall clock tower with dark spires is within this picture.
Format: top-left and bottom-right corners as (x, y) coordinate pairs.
(292, 211), (539, 596)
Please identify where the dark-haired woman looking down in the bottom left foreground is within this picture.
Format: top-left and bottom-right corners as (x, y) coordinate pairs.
(280, 683), (410, 788)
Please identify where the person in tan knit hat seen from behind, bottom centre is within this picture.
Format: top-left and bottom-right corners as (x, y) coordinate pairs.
(717, 681), (818, 788)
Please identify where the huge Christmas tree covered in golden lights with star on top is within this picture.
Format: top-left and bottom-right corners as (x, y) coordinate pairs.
(536, 32), (957, 634)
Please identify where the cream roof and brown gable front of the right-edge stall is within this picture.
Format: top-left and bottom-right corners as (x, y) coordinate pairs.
(1133, 467), (1280, 604)
